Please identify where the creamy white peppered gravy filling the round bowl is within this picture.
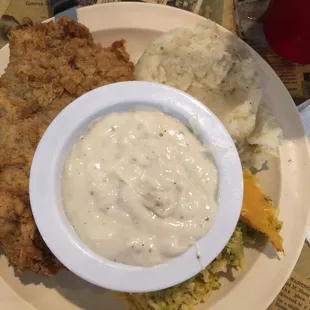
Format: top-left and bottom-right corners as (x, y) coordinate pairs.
(62, 110), (217, 266)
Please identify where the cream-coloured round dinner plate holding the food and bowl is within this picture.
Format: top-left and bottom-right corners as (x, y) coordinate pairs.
(0, 3), (310, 310)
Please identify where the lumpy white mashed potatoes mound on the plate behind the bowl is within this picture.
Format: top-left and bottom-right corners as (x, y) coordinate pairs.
(135, 20), (282, 169)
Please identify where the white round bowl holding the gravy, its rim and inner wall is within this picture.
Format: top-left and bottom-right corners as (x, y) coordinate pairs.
(29, 82), (243, 292)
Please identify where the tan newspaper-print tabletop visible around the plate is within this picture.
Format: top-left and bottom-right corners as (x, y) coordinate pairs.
(0, 0), (310, 310)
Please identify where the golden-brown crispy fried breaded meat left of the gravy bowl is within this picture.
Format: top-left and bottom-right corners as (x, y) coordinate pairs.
(0, 17), (134, 274)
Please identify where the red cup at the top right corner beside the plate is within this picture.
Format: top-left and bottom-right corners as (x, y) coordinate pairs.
(264, 0), (310, 64)
